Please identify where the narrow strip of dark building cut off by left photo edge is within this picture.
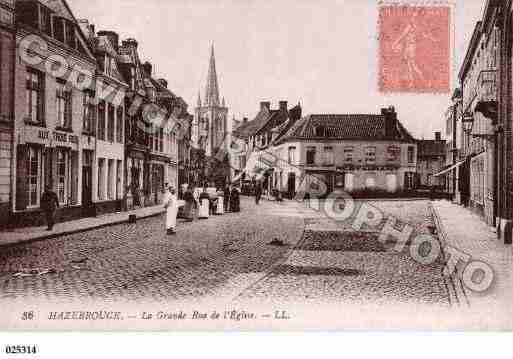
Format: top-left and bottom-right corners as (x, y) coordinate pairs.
(0, 0), (16, 227)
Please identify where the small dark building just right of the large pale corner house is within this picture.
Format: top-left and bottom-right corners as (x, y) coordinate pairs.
(417, 132), (446, 190)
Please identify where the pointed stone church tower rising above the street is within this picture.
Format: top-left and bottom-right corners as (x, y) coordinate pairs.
(193, 45), (228, 157)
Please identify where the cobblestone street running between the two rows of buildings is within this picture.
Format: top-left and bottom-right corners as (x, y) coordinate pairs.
(0, 199), (449, 306)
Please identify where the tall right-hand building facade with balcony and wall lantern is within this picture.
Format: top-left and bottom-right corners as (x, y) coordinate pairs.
(459, 6), (500, 226)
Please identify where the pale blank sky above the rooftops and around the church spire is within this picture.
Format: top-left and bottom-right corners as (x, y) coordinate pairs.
(68, 0), (485, 139)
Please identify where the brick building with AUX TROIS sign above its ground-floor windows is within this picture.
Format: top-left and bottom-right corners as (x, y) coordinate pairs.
(11, 0), (96, 225)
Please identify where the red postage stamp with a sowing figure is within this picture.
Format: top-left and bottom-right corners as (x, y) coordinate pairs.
(379, 5), (451, 93)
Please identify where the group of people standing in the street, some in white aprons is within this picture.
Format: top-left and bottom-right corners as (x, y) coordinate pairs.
(163, 184), (240, 235)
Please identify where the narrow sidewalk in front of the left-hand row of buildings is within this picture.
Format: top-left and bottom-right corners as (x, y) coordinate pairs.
(0, 205), (164, 246)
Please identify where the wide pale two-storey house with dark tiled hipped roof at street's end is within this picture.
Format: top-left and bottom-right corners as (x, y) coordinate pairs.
(274, 107), (417, 196)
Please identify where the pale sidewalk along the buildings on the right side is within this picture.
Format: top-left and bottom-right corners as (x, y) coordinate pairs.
(431, 200), (513, 326)
